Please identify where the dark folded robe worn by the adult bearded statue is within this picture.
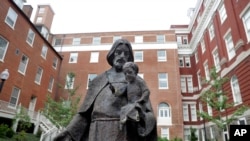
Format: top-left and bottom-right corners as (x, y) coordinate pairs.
(66, 71), (157, 141)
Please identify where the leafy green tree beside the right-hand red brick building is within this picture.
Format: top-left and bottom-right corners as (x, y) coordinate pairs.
(198, 68), (248, 140)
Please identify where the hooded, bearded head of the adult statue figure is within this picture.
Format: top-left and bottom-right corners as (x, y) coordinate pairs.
(107, 39), (134, 70)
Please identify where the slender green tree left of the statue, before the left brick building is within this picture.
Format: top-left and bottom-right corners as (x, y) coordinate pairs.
(43, 72), (80, 127)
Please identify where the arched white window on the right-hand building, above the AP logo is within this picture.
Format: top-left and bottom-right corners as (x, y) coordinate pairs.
(231, 75), (242, 105)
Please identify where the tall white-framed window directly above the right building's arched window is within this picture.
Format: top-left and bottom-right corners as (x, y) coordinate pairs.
(224, 33), (235, 60)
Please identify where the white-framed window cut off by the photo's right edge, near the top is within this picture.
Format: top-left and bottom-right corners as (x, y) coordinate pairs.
(242, 7), (250, 43)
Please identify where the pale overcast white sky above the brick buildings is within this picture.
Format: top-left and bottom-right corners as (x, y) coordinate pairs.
(26, 0), (197, 34)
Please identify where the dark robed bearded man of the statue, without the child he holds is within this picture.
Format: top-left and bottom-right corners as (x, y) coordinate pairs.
(54, 39), (157, 141)
